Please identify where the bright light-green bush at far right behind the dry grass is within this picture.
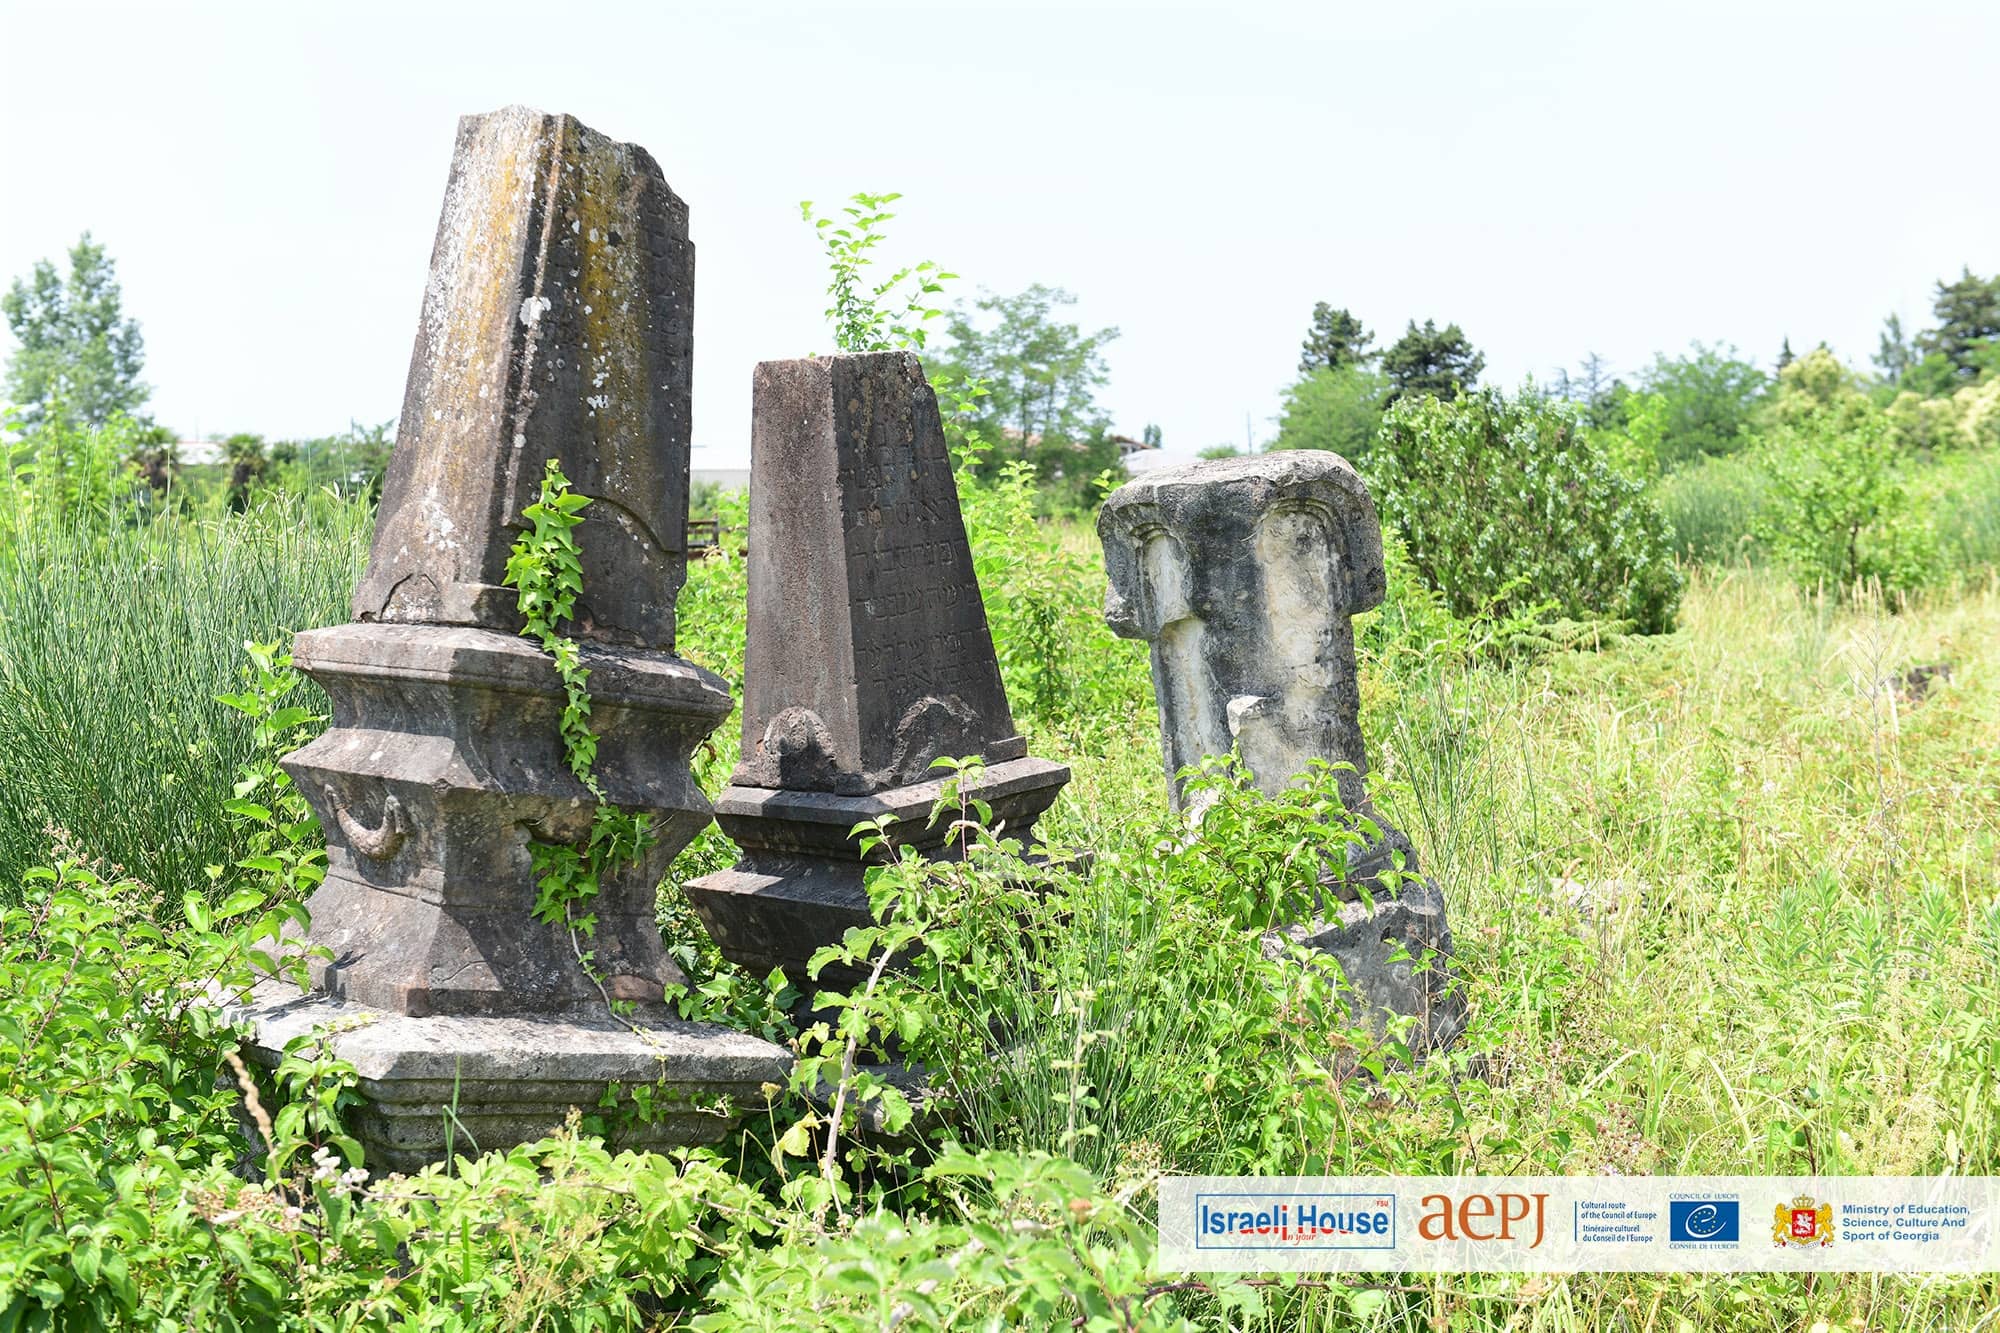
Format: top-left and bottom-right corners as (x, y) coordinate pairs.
(1756, 398), (1936, 592)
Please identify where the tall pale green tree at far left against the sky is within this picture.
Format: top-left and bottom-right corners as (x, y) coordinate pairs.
(0, 232), (148, 434)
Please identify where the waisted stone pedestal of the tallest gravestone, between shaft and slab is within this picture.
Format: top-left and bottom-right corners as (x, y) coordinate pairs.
(284, 624), (730, 1017)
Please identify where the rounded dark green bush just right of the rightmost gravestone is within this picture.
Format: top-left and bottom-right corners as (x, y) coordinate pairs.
(1366, 388), (1682, 634)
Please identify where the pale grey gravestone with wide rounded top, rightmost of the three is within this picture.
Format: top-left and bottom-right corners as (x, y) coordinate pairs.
(1098, 450), (1464, 1045)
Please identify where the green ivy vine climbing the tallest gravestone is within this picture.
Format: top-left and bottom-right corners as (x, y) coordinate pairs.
(506, 458), (652, 984)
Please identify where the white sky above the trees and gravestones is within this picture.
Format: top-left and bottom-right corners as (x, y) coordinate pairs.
(0, 0), (2000, 466)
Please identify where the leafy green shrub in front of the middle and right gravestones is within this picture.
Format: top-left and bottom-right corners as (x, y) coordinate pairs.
(796, 759), (1472, 1181)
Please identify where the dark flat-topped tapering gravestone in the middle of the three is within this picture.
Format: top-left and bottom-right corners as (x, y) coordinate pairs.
(688, 352), (1070, 985)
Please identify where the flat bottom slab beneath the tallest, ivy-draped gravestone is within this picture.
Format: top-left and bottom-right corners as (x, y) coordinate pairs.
(226, 981), (792, 1173)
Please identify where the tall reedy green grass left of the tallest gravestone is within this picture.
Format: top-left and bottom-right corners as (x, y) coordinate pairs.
(0, 496), (372, 901)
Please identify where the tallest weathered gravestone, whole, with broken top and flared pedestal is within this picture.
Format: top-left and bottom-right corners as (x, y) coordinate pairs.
(236, 108), (786, 1169)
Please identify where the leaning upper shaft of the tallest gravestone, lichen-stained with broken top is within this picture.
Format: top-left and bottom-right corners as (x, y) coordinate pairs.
(354, 106), (694, 652)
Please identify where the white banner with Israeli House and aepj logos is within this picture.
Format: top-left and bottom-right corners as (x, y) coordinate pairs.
(1158, 1175), (2000, 1273)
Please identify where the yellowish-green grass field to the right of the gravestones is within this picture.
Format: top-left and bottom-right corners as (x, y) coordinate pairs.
(1066, 572), (2000, 1329)
